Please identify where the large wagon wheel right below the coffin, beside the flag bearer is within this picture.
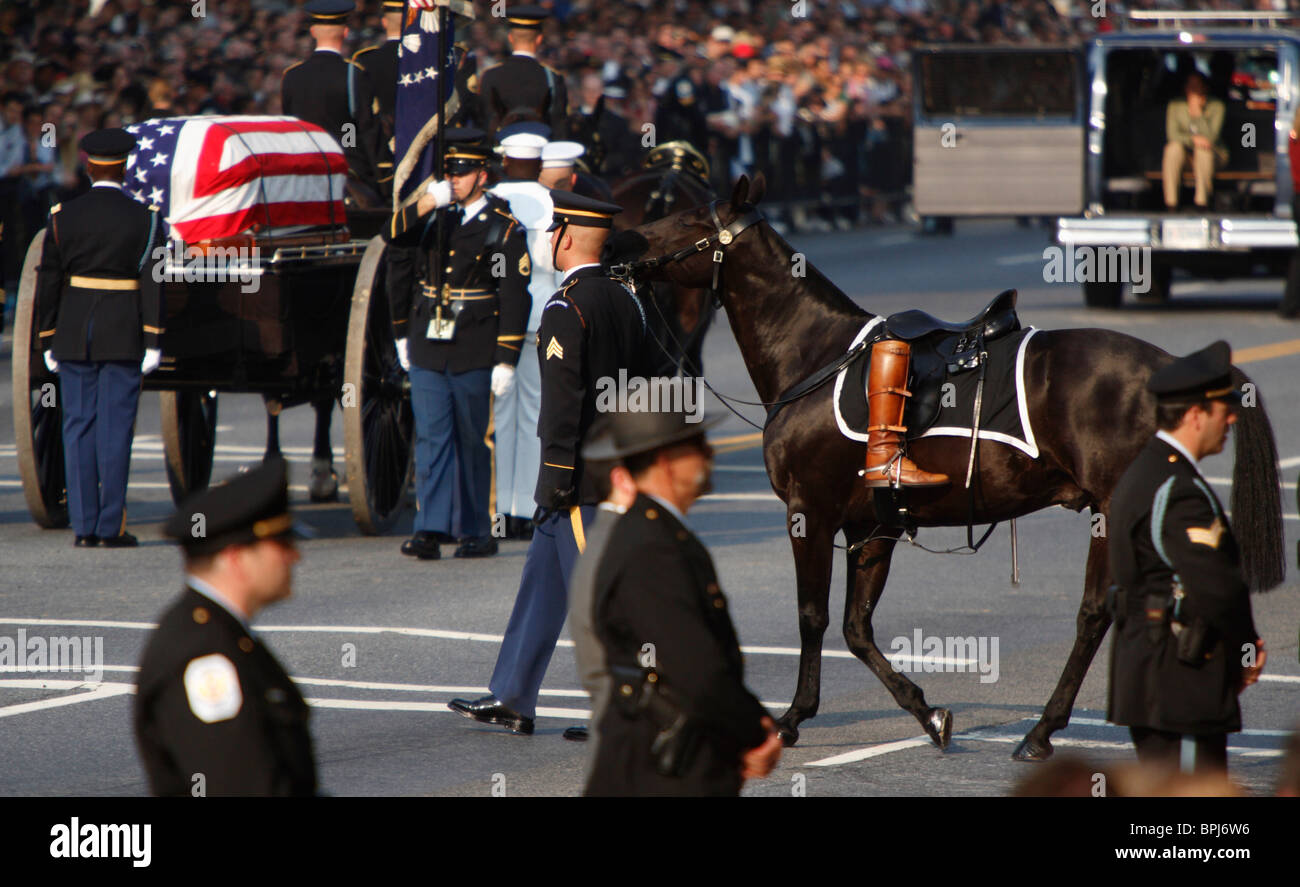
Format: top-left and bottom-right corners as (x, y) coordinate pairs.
(342, 235), (415, 536)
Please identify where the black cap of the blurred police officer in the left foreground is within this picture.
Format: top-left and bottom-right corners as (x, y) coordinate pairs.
(163, 459), (311, 557)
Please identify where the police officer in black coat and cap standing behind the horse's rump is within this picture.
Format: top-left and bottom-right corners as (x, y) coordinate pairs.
(1106, 341), (1266, 770)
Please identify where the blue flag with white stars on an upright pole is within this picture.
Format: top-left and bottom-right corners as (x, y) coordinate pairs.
(393, 0), (475, 207)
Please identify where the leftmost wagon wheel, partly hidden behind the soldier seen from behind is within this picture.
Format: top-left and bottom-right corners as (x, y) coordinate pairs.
(12, 229), (68, 529)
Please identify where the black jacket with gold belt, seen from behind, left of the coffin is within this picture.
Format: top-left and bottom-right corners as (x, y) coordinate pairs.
(36, 186), (163, 360)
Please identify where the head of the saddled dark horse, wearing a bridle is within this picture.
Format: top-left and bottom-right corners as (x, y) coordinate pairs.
(603, 173), (767, 289)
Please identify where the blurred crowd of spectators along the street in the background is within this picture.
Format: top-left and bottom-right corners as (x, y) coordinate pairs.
(0, 0), (1275, 314)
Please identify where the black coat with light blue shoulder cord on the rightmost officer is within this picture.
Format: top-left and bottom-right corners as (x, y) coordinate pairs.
(1106, 437), (1258, 734)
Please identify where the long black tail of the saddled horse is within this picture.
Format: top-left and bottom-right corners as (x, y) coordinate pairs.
(1232, 367), (1287, 592)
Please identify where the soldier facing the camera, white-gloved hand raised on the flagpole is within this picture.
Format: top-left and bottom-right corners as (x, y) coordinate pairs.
(384, 127), (532, 561)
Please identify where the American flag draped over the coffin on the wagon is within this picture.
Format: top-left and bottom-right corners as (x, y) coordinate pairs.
(125, 117), (347, 243)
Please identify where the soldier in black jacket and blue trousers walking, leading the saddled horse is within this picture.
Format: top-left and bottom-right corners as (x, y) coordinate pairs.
(450, 191), (650, 734)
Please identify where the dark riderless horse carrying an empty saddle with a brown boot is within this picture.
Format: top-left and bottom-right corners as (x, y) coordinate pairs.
(615, 176), (1286, 761)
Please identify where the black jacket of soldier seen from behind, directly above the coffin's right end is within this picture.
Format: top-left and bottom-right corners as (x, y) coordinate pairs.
(280, 49), (391, 187)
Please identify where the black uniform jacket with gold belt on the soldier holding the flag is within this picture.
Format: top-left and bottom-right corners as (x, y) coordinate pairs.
(384, 194), (532, 373)
